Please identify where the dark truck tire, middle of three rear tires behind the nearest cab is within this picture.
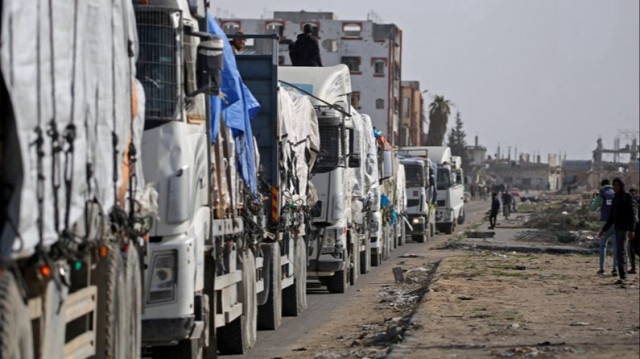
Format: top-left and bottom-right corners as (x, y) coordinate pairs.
(258, 242), (282, 330)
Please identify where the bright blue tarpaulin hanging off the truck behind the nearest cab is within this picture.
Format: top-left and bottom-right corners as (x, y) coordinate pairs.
(207, 15), (260, 194)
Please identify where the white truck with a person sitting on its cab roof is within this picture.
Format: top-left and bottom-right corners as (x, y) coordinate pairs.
(278, 65), (366, 293)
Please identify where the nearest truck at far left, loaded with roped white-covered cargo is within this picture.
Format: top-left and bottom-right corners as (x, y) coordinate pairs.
(0, 0), (155, 359)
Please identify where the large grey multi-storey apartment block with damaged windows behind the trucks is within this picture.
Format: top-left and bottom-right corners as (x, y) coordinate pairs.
(219, 11), (402, 144)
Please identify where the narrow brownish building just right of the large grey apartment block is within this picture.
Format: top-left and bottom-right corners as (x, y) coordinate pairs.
(398, 81), (427, 146)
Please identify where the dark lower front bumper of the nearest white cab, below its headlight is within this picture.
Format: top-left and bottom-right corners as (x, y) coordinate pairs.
(142, 316), (195, 346)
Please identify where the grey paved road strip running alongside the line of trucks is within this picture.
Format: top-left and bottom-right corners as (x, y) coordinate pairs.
(221, 200), (490, 359)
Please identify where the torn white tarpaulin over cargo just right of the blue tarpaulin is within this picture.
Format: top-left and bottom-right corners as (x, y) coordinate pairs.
(278, 87), (320, 204)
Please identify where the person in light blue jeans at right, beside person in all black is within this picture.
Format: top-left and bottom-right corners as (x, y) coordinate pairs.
(589, 179), (618, 276)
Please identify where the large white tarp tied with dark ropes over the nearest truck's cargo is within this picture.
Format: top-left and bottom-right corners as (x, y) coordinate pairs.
(0, 0), (137, 257)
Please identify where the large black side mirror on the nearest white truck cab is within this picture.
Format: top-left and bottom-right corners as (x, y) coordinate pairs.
(189, 36), (224, 96)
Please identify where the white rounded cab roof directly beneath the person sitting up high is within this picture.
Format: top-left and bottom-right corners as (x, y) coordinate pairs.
(278, 64), (351, 108)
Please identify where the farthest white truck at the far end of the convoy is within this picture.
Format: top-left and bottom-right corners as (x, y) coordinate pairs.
(424, 146), (465, 234)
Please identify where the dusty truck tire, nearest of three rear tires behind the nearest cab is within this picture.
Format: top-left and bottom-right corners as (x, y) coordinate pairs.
(217, 250), (258, 355)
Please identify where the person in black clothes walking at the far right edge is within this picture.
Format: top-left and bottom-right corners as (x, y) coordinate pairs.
(598, 177), (638, 284)
